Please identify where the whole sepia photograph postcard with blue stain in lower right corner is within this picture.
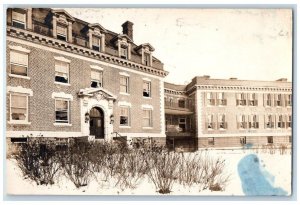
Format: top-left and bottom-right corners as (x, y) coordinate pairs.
(3, 5), (295, 197)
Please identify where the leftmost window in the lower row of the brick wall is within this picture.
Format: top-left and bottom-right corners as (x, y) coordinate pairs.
(10, 93), (28, 122)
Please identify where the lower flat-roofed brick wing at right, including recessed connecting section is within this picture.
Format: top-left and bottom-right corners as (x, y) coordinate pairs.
(165, 76), (292, 147)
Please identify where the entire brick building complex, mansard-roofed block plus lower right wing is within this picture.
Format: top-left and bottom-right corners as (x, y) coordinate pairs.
(6, 8), (292, 148)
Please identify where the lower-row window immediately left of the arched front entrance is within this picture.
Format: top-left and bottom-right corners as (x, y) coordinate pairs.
(55, 99), (69, 123)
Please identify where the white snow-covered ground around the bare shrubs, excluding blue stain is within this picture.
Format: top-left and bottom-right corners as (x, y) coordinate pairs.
(6, 149), (292, 196)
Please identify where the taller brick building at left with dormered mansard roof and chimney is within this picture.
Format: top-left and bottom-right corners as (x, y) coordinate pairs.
(6, 8), (167, 143)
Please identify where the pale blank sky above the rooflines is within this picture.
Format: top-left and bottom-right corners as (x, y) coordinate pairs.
(66, 8), (292, 84)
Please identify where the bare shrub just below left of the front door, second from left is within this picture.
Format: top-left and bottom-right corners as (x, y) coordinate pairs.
(63, 141), (93, 188)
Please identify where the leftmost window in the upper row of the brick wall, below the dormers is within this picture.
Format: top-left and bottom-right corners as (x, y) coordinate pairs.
(10, 50), (28, 76)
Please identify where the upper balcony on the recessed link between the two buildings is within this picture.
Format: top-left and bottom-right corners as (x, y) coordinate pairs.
(165, 102), (194, 115)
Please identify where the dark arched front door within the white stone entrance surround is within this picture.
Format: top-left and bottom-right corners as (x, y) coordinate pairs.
(90, 107), (104, 139)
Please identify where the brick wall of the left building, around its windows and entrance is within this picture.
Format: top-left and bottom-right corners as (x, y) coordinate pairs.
(6, 41), (161, 136)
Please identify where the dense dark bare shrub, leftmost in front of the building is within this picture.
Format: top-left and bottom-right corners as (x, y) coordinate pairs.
(16, 139), (61, 185)
